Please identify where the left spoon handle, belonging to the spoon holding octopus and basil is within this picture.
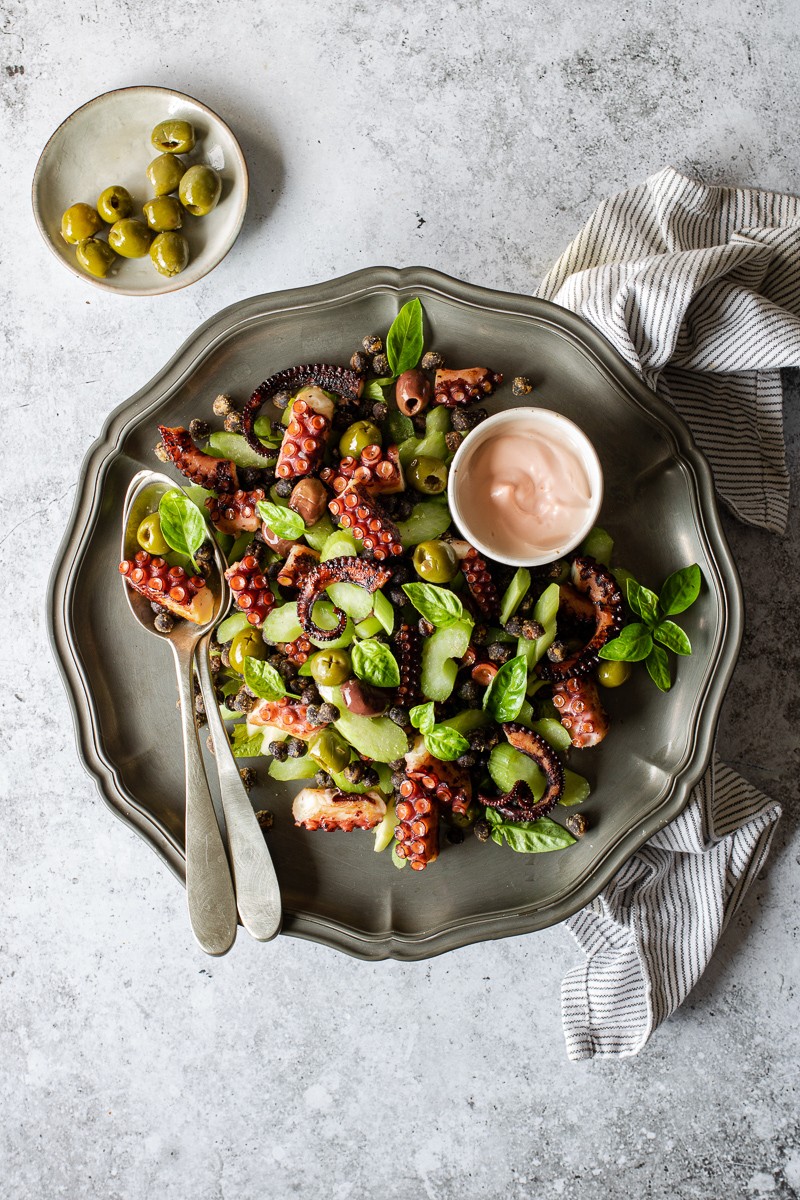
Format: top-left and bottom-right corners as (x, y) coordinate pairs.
(170, 643), (236, 955)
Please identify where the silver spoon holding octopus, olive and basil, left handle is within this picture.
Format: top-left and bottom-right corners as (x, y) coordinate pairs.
(122, 470), (237, 955)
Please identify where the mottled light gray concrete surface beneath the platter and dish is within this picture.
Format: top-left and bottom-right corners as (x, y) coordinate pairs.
(0, 0), (800, 1200)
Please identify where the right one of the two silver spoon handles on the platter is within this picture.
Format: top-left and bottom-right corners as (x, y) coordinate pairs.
(197, 634), (282, 942)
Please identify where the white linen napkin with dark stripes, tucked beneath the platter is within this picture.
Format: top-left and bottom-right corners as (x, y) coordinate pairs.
(537, 167), (800, 1060)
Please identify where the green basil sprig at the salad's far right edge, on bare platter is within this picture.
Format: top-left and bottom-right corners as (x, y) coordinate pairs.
(600, 563), (703, 691)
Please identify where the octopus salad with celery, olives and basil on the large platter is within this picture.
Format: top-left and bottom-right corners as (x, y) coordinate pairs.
(120, 299), (702, 870)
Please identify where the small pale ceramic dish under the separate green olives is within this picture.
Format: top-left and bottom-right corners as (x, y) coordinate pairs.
(32, 88), (248, 296)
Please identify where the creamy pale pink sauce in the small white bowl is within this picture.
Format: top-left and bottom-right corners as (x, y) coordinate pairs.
(461, 428), (593, 558)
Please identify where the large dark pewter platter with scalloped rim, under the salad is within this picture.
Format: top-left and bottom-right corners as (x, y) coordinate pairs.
(50, 268), (742, 959)
